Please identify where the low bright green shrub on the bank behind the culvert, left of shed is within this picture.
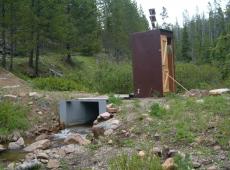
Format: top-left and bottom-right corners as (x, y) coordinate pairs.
(33, 77), (85, 91)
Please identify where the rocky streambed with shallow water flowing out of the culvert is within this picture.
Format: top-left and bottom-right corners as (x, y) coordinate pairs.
(0, 105), (120, 170)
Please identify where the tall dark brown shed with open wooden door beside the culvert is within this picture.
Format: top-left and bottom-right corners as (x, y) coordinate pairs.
(132, 29), (176, 97)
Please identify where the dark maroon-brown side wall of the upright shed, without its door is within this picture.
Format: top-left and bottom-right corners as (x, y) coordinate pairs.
(132, 30), (163, 97)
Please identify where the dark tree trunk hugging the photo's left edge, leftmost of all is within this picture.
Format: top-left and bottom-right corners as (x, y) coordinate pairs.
(2, 2), (6, 68)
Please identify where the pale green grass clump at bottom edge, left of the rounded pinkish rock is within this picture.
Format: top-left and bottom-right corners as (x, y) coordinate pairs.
(109, 154), (162, 170)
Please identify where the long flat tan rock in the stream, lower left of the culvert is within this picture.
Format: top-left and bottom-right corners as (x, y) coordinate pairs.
(24, 139), (51, 152)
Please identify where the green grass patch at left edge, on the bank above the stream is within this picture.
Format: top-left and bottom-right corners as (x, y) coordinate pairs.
(0, 101), (29, 135)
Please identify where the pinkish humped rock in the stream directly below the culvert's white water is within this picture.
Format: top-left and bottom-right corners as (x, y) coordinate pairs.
(64, 133), (91, 145)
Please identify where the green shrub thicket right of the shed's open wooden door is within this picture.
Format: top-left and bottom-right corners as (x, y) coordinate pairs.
(176, 63), (221, 91)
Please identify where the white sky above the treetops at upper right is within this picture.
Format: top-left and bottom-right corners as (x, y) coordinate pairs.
(136, 0), (227, 25)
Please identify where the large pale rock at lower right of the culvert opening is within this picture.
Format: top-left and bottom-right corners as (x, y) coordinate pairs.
(92, 118), (120, 136)
